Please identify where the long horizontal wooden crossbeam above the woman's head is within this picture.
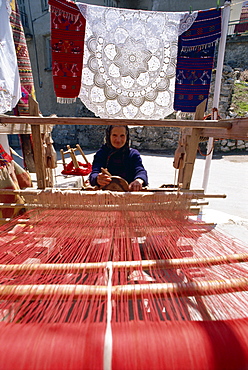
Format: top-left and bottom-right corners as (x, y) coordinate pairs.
(0, 115), (233, 129)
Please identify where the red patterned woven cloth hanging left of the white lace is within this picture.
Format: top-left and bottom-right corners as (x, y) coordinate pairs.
(49, 0), (85, 103)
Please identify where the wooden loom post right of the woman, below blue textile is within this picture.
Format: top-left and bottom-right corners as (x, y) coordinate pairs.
(178, 100), (207, 189)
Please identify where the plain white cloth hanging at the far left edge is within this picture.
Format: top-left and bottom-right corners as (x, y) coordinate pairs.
(0, 0), (21, 113)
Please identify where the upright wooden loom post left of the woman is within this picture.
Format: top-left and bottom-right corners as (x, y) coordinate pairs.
(28, 95), (46, 189)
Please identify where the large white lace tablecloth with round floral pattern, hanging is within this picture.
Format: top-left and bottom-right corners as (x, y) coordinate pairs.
(77, 3), (197, 119)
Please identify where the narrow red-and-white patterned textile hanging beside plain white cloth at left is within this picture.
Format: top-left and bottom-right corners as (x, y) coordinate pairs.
(10, 1), (35, 115)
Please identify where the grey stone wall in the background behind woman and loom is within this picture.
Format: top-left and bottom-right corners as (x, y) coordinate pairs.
(53, 65), (248, 153)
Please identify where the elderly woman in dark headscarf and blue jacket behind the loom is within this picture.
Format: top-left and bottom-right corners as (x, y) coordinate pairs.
(89, 125), (148, 191)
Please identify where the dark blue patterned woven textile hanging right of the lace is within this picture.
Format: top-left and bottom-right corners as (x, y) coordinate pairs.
(174, 9), (221, 112)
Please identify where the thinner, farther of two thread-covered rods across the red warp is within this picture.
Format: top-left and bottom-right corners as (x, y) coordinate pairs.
(0, 253), (248, 274)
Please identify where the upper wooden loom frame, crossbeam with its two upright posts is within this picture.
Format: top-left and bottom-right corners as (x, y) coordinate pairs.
(0, 96), (248, 189)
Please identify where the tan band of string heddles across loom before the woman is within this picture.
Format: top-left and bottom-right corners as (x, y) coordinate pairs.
(22, 189), (195, 212)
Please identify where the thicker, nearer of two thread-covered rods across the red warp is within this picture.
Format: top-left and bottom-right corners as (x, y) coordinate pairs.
(0, 278), (248, 301)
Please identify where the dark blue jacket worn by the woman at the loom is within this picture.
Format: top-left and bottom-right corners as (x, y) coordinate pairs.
(89, 144), (148, 186)
